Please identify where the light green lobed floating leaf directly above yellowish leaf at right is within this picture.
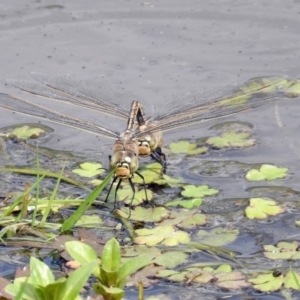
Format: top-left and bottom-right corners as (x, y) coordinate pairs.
(246, 164), (288, 181)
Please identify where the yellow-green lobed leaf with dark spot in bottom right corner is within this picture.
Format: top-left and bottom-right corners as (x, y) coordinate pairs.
(248, 271), (300, 292)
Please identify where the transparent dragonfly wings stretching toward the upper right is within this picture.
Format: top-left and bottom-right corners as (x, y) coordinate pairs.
(135, 77), (286, 138)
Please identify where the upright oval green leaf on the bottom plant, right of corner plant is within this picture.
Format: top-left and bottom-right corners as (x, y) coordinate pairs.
(101, 238), (121, 272)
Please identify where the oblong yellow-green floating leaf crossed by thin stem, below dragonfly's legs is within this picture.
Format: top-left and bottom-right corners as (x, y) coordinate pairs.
(118, 206), (170, 222)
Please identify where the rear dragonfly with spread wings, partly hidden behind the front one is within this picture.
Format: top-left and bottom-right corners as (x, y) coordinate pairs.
(8, 73), (285, 173)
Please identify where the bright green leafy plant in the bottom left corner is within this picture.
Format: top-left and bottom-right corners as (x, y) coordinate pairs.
(5, 257), (95, 300)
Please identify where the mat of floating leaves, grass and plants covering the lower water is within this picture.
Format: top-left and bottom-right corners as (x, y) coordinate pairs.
(0, 78), (300, 300)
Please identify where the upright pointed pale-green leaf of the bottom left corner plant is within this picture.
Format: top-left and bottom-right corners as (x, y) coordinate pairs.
(30, 256), (54, 287)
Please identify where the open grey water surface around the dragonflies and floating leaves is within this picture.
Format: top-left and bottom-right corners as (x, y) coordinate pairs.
(0, 0), (300, 299)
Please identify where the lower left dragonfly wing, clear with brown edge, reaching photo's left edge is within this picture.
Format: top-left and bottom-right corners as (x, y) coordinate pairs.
(0, 94), (119, 139)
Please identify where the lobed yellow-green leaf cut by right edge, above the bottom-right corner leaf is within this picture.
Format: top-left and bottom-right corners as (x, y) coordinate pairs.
(263, 241), (300, 260)
